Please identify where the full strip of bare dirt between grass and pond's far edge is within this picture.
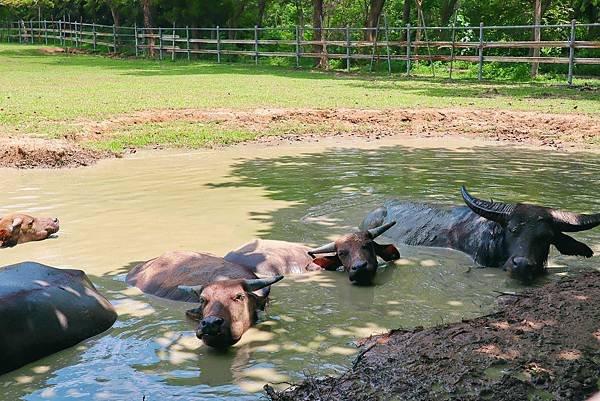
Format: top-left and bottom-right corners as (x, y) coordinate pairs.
(0, 108), (600, 168)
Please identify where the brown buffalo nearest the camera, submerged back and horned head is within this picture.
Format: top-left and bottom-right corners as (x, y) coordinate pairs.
(127, 252), (283, 348)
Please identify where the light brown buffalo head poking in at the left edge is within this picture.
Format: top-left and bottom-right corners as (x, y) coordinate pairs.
(0, 213), (59, 248)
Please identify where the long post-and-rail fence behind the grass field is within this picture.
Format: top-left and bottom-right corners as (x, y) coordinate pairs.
(0, 16), (600, 85)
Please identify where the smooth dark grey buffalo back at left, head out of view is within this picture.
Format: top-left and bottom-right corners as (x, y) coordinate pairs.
(0, 262), (117, 374)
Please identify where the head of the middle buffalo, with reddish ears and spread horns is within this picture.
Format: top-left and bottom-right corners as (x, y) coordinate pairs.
(308, 221), (400, 285)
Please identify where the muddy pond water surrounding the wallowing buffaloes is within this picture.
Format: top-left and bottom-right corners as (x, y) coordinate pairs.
(0, 139), (600, 400)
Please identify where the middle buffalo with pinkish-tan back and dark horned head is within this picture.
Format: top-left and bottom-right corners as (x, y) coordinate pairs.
(225, 222), (400, 284)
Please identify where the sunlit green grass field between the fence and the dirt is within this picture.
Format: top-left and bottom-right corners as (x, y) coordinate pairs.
(0, 44), (600, 149)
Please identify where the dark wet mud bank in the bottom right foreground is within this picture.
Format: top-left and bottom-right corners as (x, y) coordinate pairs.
(265, 272), (600, 401)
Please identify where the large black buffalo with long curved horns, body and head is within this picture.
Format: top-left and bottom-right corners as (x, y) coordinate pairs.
(361, 187), (600, 280)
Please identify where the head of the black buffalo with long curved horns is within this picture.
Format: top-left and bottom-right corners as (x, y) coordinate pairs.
(461, 187), (600, 280)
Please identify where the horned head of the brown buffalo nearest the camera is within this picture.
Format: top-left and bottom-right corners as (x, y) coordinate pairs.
(179, 276), (283, 348)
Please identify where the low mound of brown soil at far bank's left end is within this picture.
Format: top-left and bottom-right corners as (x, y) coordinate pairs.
(0, 138), (115, 169)
